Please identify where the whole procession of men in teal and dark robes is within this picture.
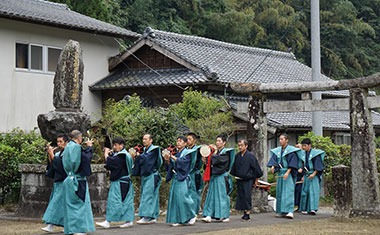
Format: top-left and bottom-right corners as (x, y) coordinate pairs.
(42, 130), (324, 234)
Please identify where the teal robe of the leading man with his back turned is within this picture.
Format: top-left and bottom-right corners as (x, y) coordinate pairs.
(62, 141), (95, 234)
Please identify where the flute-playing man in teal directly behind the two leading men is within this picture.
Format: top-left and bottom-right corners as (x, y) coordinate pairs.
(96, 137), (135, 228)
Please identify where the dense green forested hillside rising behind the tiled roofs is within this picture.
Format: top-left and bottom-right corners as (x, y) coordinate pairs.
(54, 0), (380, 79)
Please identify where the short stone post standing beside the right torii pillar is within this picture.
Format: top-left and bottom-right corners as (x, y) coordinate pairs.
(332, 165), (352, 217)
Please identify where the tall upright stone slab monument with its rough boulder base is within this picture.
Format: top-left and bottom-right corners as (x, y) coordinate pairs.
(37, 40), (91, 143)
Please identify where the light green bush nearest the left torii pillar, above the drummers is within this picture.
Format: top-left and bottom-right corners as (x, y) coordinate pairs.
(170, 91), (234, 144)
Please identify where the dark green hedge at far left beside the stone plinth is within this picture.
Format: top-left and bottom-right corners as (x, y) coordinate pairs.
(0, 129), (46, 202)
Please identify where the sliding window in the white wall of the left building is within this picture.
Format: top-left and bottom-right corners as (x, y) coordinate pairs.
(16, 43), (62, 72)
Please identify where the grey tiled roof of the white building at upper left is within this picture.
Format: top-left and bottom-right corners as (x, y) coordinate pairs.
(0, 0), (141, 38)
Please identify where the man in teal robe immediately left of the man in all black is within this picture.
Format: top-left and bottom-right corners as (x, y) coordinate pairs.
(202, 134), (235, 223)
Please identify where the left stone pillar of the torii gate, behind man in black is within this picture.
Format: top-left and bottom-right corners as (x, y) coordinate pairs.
(247, 93), (268, 212)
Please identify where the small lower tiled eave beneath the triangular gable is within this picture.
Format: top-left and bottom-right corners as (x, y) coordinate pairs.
(90, 69), (208, 90)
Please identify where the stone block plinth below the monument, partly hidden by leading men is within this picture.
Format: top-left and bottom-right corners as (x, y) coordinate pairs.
(17, 164), (109, 218)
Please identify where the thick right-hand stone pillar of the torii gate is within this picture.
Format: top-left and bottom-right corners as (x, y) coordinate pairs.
(350, 88), (380, 217)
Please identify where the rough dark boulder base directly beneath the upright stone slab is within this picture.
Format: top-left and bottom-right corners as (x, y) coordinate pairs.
(37, 111), (91, 143)
